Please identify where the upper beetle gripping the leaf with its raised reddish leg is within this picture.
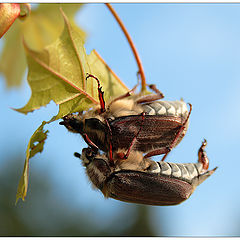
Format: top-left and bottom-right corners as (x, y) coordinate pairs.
(60, 75), (192, 162)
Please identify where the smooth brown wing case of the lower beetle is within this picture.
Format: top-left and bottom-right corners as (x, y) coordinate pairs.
(102, 171), (193, 206)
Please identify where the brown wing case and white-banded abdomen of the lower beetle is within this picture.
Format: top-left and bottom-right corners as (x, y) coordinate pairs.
(101, 162), (216, 206)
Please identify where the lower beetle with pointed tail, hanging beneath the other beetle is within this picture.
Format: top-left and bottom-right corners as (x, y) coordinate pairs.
(75, 140), (217, 206)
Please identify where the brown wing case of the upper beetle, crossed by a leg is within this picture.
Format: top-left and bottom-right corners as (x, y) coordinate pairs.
(110, 115), (185, 152)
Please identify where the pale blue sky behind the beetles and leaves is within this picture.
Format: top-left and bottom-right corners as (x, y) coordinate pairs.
(0, 4), (240, 236)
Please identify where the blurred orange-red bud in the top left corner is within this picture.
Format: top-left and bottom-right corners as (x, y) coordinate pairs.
(0, 3), (20, 38)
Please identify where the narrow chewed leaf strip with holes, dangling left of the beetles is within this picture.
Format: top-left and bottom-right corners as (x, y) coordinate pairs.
(16, 120), (51, 204)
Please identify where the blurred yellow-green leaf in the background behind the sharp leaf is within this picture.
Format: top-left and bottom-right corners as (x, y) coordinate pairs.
(0, 3), (85, 87)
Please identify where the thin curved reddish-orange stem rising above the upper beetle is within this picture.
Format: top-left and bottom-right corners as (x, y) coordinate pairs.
(105, 3), (146, 91)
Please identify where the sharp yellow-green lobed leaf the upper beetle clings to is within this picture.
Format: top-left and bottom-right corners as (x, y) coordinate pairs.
(16, 9), (128, 120)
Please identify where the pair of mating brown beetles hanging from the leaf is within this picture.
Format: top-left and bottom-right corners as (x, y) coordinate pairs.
(61, 75), (216, 206)
